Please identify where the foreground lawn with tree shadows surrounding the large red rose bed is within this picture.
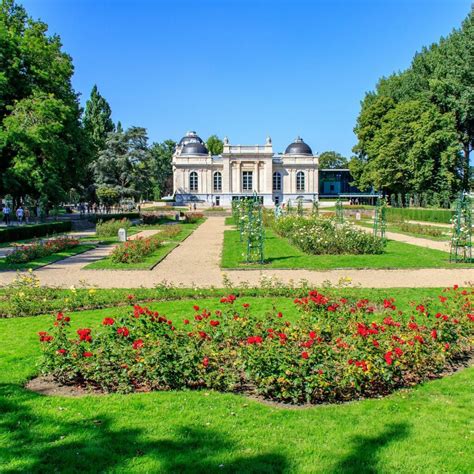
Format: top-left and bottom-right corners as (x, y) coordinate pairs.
(0, 290), (474, 473)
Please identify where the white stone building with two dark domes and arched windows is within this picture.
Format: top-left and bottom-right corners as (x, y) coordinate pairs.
(173, 132), (318, 206)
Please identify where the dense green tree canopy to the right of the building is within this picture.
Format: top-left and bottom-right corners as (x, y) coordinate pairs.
(350, 11), (474, 196)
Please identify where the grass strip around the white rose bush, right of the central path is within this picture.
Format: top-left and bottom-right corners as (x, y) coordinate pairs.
(222, 229), (468, 270)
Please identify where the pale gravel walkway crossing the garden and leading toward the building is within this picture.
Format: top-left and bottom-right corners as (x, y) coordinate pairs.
(0, 217), (474, 288)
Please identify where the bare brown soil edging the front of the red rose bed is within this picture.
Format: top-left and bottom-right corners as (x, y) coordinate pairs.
(25, 350), (474, 410)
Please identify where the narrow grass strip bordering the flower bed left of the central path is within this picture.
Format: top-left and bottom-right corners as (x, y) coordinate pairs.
(84, 222), (200, 270)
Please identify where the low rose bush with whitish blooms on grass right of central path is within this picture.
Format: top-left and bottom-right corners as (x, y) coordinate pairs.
(273, 216), (385, 255)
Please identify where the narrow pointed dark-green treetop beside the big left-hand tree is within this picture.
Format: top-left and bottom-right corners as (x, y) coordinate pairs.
(83, 85), (115, 154)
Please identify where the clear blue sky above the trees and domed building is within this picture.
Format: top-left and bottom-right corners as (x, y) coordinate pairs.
(20, 0), (471, 156)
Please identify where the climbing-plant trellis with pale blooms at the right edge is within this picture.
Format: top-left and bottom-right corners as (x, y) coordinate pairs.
(449, 194), (472, 263)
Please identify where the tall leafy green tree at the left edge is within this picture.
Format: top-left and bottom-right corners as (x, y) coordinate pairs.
(0, 0), (90, 206)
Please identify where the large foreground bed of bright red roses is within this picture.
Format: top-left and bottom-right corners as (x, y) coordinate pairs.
(39, 287), (474, 403)
